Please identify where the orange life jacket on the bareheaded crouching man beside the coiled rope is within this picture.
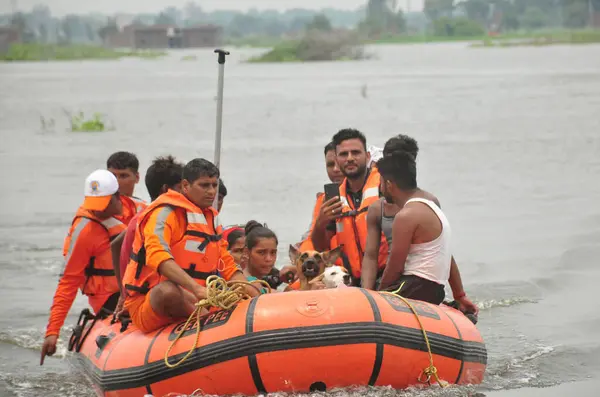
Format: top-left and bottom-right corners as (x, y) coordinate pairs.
(123, 190), (223, 296)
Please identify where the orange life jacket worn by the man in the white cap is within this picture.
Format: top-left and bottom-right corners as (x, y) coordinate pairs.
(63, 208), (127, 296)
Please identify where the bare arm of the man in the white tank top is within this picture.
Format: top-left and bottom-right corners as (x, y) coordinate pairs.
(379, 208), (418, 290)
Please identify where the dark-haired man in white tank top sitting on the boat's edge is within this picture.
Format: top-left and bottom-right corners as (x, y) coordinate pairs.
(377, 152), (464, 304)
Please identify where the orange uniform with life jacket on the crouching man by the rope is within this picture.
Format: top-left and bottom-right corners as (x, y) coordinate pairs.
(123, 190), (240, 332)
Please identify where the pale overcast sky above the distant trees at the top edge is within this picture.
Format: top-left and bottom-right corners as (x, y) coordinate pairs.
(0, 0), (423, 16)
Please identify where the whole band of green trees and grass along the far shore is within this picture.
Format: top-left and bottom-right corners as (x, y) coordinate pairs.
(0, 0), (600, 63)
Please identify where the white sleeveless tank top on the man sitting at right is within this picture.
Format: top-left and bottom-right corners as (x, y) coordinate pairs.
(404, 198), (452, 284)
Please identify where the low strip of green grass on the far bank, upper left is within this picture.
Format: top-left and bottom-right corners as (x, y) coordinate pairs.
(0, 43), (167, 62)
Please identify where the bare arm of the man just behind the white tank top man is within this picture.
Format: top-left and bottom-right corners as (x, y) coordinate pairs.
(361, 201), (381, 290)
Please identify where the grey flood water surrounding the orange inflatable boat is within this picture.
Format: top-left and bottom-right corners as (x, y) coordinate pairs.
(0, 44), (600, 397)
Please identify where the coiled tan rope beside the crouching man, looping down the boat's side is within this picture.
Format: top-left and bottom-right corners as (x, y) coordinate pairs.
(165, 275), (271, 368)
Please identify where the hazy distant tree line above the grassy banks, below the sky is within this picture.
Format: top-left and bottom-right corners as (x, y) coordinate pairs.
(0, 0), (600, 44)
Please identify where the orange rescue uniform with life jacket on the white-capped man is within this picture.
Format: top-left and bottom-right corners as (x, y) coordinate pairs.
(46, 208), (125, 336)
